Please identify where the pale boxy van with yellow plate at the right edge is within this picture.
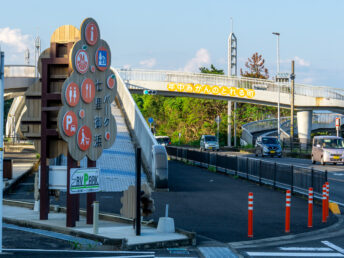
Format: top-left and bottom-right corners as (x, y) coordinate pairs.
(312, 136), (344, 165)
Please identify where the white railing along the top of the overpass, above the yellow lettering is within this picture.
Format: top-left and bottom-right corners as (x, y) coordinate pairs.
(118, 69), (344, 100)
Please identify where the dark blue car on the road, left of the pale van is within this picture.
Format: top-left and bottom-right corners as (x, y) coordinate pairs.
(255, 136), (282, 158)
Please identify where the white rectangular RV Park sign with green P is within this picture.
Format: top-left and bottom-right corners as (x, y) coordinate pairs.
(69, 168), (100, 194)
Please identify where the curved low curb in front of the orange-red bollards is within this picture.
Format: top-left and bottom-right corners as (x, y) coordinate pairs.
(227, 216), (344, 249)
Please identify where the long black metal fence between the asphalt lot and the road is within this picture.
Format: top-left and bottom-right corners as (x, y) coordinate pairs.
(166, 146), (327, 198)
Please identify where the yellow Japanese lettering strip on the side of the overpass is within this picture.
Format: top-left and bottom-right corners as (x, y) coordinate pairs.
(167, 82), (256, 99)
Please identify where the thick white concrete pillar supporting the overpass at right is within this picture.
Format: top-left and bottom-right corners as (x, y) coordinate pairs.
(297, 110), (313, 149)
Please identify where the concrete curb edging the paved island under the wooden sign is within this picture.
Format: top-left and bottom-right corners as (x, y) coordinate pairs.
(3, 199), (196, 250)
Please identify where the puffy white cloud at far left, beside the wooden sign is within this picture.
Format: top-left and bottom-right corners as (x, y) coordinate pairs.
(0, 27), (34, 64)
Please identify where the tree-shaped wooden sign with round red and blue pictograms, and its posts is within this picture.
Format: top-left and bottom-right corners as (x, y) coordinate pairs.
(58, 18), (117, 227)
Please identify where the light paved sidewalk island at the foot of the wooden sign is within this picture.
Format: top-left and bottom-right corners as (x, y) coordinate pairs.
(3, 201), (194, 250)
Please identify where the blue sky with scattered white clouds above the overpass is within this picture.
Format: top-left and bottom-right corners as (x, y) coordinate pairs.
(0, 0), (344, 89)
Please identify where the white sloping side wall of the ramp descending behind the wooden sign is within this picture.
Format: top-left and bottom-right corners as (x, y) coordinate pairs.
(113, 69), (168, 188)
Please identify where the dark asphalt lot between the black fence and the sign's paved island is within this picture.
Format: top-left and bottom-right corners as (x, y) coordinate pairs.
(5, 161), (336, 242)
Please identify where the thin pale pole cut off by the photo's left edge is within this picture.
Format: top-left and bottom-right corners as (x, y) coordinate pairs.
(0, 45), (5, 253)
